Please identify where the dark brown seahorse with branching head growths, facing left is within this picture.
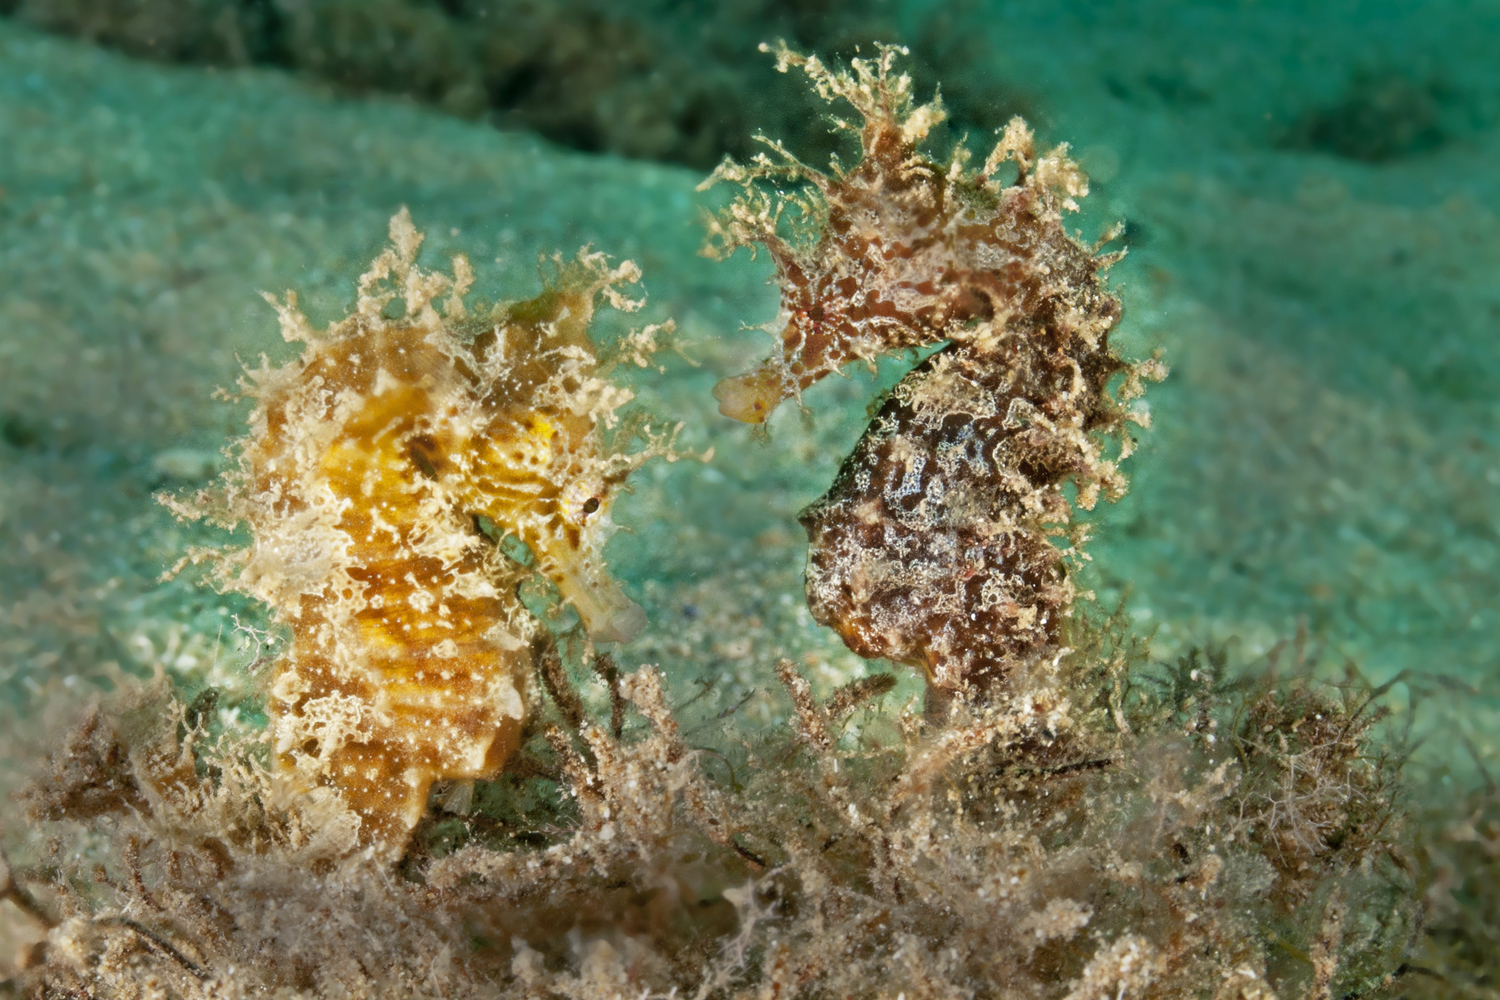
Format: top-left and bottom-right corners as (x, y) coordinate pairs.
(705, 43), (1166, 690)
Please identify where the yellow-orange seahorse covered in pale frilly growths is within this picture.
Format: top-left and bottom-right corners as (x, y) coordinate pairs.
(172, 208), (671, 858)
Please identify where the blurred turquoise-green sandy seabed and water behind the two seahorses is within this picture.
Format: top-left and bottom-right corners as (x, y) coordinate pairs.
(0, 1), (1500, 753)
